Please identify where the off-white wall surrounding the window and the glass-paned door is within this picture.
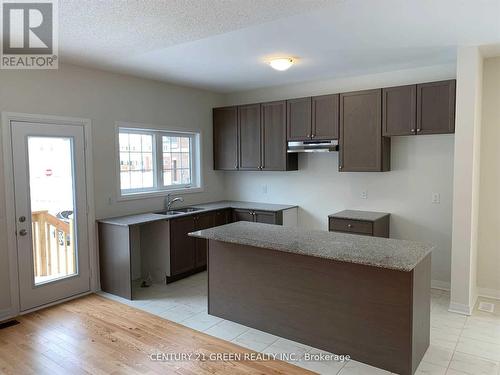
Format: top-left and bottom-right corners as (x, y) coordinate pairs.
(0, 64), (224, 315)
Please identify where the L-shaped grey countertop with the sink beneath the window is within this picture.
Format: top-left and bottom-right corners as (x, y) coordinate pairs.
(98, 201), (297, 226)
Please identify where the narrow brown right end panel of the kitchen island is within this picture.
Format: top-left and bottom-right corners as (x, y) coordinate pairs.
(412, 254), (431, 373)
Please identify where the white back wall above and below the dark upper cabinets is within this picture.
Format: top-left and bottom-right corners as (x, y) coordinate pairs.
(225, 65), (455, 286)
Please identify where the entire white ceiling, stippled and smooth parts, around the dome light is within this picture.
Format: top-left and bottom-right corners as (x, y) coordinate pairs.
(59, 0), (500, 92)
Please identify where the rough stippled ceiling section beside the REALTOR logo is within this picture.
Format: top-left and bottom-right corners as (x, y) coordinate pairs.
(59, 0), (332, 60)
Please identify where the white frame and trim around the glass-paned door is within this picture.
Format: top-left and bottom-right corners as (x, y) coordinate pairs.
(0, 112), (99, 320)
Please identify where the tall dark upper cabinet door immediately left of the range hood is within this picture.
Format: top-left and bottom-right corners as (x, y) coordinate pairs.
(262, 101), (287, 171)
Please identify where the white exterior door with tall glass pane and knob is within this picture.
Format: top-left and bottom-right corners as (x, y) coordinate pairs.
(11, 121), (90, 311)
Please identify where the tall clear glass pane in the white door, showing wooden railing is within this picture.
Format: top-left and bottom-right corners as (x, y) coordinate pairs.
(28, 136), (78, 285)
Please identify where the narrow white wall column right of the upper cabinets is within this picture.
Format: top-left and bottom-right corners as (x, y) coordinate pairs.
(450, 47), (483, 315)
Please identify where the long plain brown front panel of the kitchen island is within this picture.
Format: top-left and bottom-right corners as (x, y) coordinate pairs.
(208, 240), (413, 375)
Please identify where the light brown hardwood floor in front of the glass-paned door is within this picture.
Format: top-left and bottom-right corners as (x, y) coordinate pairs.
(0, 295), (312, 375)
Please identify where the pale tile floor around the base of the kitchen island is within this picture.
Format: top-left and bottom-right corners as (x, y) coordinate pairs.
(102, 272), (500, 375)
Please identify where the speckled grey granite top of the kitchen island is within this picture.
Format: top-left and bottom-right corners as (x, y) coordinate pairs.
(190, 221), (434, 271)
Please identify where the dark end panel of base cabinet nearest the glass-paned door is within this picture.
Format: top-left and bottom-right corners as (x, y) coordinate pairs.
(99, 223), (132, 299)
